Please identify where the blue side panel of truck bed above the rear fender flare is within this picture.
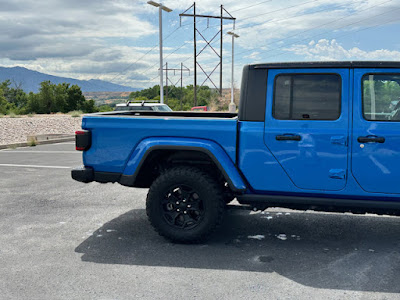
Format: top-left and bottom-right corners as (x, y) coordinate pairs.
(82, 111), (237, 173)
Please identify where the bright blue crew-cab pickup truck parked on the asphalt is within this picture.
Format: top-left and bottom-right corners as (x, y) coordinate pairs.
(72, 62), (400, 242)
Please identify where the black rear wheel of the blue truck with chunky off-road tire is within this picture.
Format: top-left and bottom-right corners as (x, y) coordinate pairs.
(146, 166), (225, 243)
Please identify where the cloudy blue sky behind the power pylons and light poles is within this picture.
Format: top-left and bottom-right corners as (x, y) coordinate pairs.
(0, 0), (400, 88)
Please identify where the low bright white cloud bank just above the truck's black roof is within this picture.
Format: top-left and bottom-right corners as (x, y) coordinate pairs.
(285, 39), (400, 61)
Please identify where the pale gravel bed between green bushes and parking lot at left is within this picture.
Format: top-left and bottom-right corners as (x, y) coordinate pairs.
(0, 114), (82, 145)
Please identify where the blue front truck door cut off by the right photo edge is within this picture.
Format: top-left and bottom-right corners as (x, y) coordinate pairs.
(351, 69), (400, 194)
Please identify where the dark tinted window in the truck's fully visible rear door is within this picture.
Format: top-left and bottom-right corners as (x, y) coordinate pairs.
(272, 74), (341, 120)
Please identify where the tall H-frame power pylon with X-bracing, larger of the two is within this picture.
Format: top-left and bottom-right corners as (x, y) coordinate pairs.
(179, 2), (236, 106)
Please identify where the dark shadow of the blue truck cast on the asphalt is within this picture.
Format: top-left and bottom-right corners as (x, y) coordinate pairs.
(75, 209), (400, 293)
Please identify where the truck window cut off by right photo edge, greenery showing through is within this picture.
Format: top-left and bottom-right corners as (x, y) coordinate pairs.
(362, 73), (400, 122)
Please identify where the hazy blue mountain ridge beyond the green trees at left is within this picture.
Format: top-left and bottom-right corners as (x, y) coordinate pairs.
(0, 67), (140, 93)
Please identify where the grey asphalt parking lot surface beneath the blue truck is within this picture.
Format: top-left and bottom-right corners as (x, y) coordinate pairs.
(0, 143), (400, 299)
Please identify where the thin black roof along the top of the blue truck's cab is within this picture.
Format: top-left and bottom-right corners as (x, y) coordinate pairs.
(249, 61), (400, 69)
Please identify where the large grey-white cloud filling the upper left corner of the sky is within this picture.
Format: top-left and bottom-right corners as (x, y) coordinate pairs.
(0, 0), (157, 60)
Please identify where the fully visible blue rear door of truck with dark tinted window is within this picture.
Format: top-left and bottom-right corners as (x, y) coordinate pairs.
(264, 69), (349, 191)
